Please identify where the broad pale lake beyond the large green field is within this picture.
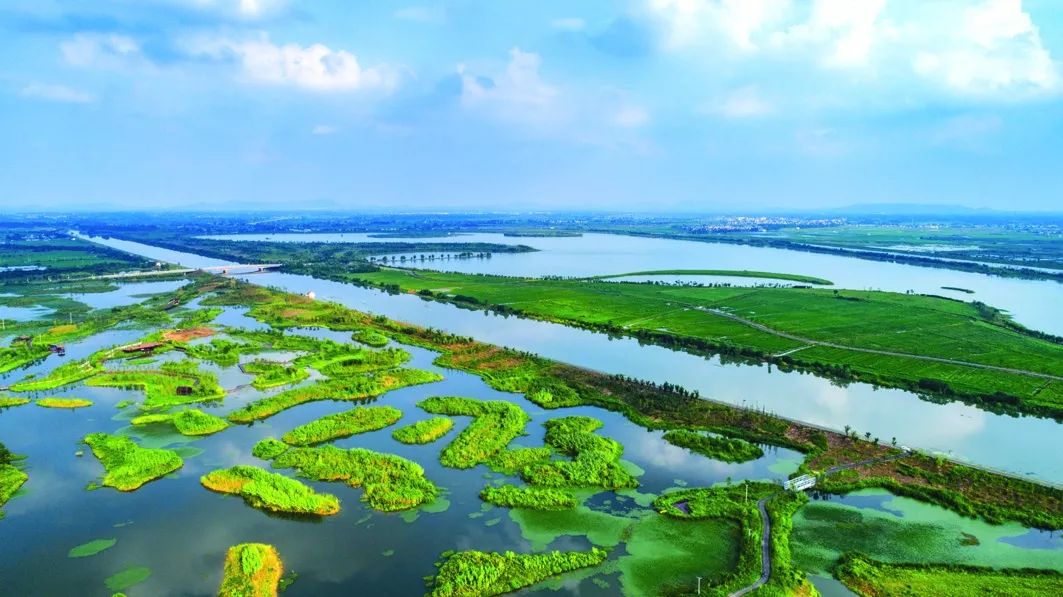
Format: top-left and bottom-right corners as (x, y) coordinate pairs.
(207, 233), (1063, 336)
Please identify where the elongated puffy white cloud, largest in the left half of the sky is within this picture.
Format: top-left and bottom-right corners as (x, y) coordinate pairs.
(184, 34), (399, 91)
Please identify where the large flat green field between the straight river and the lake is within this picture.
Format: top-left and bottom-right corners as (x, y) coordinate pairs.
(346, 270), (1063, 416)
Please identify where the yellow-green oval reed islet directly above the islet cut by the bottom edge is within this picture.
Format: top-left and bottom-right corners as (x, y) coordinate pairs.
(200, 466), (339, 516)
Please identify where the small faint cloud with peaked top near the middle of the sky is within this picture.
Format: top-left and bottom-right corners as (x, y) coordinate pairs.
(458, 48), (559, 122)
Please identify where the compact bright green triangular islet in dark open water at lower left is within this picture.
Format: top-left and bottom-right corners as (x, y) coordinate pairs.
(85, 433), (184, 491)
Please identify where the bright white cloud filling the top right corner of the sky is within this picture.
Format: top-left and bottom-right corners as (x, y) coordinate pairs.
(912, 0), (1060, 97)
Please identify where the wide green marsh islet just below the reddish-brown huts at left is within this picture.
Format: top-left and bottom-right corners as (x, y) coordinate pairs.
(85, 360), (225, 408)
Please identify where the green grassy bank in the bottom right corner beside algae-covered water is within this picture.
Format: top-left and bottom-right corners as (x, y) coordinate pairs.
(834, 555), (1063, 597)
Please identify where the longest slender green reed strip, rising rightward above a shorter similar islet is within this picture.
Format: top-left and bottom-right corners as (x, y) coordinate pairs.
(229, 369), (443, 423)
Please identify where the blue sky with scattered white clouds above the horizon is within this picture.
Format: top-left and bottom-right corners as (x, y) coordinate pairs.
(0, 0), (1063, 211)
